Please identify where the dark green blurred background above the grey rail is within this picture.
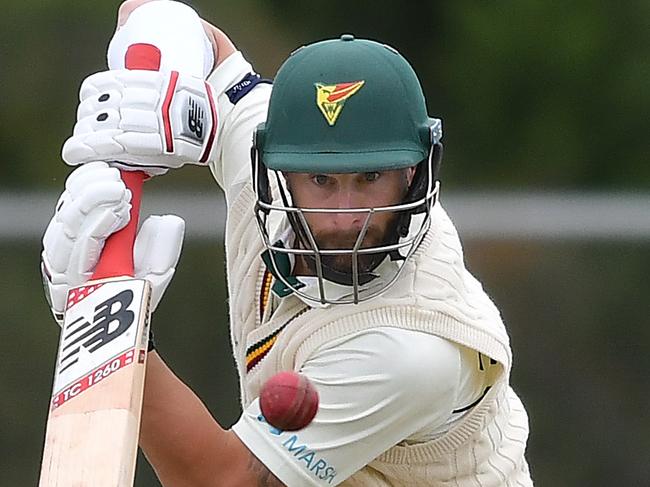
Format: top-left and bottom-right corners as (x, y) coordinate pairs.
(0, 0), (650, 189)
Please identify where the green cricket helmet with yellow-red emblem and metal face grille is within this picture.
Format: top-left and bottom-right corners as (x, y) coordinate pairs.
(252, 34), (442, 303)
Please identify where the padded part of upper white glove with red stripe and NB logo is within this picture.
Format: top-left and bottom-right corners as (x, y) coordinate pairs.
(62, 69), (218, 176)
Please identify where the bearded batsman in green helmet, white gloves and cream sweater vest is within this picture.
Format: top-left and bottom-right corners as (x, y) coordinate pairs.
(42, 0), (532, 487)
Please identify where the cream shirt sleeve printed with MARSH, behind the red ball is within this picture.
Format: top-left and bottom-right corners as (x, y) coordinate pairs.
(233, 327), (461, 486)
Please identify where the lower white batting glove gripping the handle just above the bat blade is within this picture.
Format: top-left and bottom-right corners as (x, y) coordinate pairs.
(41, 162), (185, 324)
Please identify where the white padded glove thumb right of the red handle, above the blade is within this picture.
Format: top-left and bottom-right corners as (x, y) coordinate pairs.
(134, 215), (185, 310)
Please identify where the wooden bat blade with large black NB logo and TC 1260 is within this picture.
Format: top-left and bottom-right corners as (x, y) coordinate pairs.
(39, 277), (151, 487)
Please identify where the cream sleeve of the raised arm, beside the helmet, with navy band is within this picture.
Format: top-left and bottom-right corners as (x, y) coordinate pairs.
(207, 51), (271, 201)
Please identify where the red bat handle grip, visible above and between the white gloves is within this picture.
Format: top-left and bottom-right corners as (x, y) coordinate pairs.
(92, 44), (161, 280)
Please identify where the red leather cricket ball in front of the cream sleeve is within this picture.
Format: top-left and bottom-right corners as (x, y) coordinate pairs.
(260, 372), (318, 431)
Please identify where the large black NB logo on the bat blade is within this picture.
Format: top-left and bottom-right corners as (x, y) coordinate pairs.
(59, 289), (135, 373)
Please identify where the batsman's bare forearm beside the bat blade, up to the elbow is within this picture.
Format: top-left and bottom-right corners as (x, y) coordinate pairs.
(140, 352), (241, 487)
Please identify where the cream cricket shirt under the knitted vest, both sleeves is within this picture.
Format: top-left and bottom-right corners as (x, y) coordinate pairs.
(210, 53), (496, 486)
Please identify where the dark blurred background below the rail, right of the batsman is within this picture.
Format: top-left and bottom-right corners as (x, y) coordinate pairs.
(467, 242), (650, 487)
